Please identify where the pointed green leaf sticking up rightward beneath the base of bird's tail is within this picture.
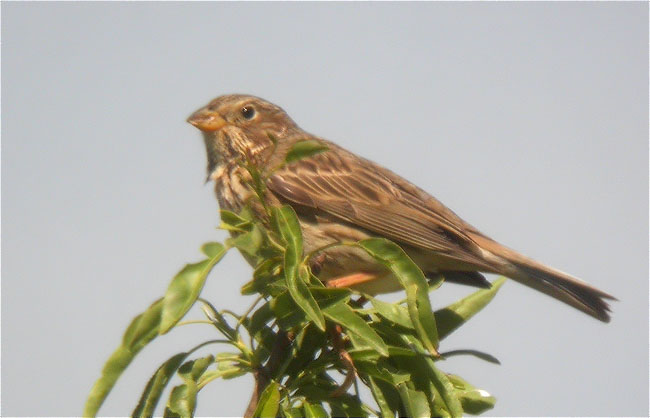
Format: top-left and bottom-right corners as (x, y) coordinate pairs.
(435, 277), (506, 339)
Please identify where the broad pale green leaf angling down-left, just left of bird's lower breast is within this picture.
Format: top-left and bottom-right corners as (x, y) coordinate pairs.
(158, 243), (226, 335)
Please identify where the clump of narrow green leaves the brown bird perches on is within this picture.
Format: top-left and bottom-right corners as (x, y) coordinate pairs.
(84, 145), (504, 417)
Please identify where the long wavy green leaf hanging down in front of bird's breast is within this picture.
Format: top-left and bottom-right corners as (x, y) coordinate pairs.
(273, 205), (325, 331)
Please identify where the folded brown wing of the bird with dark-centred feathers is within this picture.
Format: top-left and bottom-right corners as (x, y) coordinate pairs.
(268, 141), (492, 271)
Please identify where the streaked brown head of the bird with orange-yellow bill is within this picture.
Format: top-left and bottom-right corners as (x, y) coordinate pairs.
(187, 94), (298, 178)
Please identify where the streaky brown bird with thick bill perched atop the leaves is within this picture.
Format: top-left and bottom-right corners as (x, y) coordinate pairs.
(187, 94), (616, 322)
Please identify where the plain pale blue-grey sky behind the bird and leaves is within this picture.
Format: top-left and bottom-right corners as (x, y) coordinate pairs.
(1, 2), (648, 416)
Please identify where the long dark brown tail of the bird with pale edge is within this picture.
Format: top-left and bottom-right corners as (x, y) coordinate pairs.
(470, 240), (616, 322)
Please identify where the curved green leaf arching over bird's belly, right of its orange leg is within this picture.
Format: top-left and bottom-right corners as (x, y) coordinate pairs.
(358, 238), (438, 355)
